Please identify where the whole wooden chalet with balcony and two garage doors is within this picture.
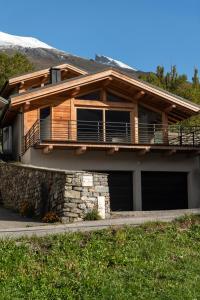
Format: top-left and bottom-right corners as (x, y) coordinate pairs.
(0, 64), (200, 210)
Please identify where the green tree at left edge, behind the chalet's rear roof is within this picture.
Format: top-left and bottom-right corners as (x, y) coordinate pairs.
(0, 53), (34, 88)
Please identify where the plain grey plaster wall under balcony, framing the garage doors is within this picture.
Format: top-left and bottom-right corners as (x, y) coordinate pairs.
(22, 148), (200, 210)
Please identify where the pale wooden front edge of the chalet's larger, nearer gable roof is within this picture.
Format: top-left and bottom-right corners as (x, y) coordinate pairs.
(11, 68), (200, 113)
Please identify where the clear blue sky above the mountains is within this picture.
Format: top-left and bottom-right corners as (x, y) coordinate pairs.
(0, 0), (200, 78)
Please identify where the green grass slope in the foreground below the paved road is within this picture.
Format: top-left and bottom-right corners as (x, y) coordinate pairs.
(0, 216), (200, 300)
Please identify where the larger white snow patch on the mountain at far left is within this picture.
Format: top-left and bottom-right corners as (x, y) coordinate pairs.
(0, 32), (54, 49)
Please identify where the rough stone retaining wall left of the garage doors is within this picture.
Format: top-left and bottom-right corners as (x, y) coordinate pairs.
(0, 162), (110, 223)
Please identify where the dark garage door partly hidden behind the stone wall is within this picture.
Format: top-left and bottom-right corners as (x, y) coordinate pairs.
(106, 171), (133, 211)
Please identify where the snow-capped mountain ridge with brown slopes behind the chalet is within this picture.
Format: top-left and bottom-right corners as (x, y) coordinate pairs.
(0, 32), (140, 76)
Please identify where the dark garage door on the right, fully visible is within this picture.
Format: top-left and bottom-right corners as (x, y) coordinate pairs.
(142, 172), (188, 210)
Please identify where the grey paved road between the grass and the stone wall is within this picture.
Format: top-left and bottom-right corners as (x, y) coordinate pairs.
(0, 208), (200, 238)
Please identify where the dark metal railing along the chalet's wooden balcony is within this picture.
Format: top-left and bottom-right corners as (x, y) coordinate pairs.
(24, 119), (200, 152)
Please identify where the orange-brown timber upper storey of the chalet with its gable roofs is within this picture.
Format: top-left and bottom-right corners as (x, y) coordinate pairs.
(0, 65), (200, 153)
